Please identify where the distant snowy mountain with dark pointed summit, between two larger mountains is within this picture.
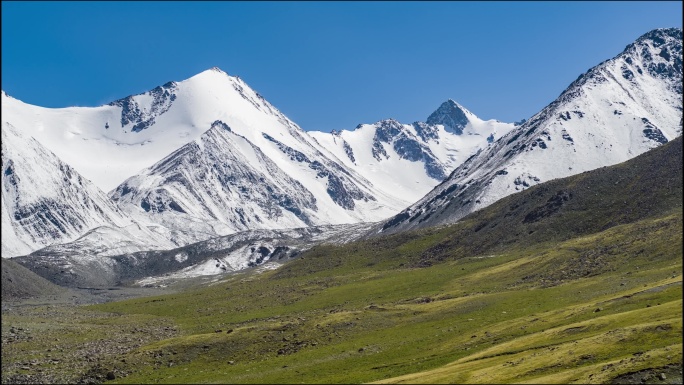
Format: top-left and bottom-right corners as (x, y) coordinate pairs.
(309, 99), (513, 206)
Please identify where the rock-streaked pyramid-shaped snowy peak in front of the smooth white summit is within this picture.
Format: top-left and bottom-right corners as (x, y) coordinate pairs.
(111, 121), (316, 244)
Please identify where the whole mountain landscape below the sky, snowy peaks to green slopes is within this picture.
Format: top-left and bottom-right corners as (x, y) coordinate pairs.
(1, 28), (684, 384)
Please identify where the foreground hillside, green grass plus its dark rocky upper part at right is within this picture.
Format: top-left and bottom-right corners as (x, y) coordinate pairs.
(3, 139), (682, 383)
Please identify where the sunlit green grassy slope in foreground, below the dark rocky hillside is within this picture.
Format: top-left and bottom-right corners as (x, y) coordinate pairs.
(88, 213), (682, 383)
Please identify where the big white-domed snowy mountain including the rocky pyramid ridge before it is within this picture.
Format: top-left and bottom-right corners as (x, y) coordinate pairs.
(2, 68), (456, 255)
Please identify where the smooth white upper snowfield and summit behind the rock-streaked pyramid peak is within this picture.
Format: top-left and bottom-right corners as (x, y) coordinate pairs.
(2, 68), (374, 191)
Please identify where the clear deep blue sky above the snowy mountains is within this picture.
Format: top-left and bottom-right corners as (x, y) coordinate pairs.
(2, 1), (682, 131)
